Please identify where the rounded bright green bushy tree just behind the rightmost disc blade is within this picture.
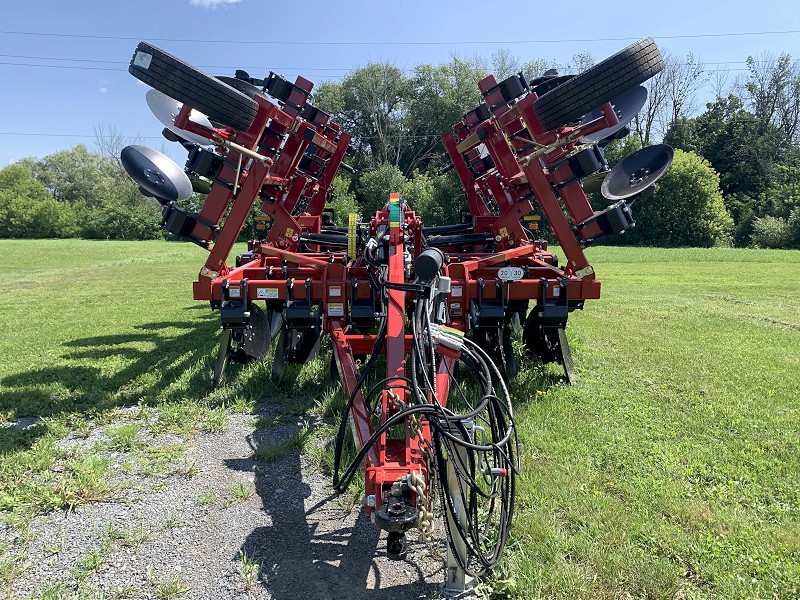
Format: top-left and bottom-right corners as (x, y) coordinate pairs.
(624, 150), (733, 247)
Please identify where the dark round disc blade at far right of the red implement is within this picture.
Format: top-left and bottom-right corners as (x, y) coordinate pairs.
(600, 144), (673, 200)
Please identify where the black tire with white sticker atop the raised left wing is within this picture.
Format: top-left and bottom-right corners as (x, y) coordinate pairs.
(128, 42), (258, 131)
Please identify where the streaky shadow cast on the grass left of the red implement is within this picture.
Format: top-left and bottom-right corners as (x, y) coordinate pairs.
(0, 313), (219, 426)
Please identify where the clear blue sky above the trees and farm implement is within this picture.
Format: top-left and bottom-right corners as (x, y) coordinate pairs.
(0, 0), (800, 167)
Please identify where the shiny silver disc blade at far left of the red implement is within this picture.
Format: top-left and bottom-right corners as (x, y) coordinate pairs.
(120, 146), (192, 204)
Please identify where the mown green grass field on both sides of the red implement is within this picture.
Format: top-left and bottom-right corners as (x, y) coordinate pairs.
(0, 240), (800, 598)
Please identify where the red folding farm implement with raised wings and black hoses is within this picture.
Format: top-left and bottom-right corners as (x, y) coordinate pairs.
(122, 39), (672, 588)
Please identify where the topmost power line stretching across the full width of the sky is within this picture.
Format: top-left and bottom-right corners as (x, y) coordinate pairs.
(0, 29), (800, 46)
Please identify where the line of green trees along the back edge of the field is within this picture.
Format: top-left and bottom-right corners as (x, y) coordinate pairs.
(0, 51), (800, 248)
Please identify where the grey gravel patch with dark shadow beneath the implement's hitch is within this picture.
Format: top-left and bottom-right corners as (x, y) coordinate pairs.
(2, 415), (472, 600)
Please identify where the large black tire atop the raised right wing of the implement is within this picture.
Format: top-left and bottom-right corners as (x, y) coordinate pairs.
(533, 38), (664, 130)
